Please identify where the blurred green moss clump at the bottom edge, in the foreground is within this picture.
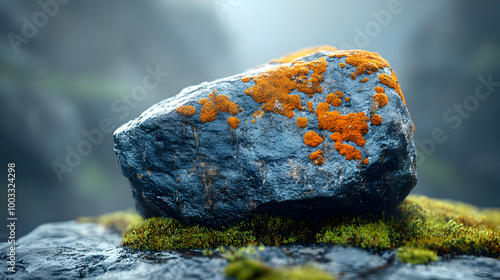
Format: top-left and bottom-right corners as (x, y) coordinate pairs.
(224, 259), (335, 280)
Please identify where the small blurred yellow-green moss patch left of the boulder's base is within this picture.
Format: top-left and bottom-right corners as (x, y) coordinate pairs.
(76, 209), (142, 233)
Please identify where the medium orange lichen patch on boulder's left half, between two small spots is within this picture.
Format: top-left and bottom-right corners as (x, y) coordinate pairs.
(200, 90), (241, 123)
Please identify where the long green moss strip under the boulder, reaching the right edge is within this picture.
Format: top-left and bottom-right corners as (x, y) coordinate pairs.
(122, 195), (500, 257)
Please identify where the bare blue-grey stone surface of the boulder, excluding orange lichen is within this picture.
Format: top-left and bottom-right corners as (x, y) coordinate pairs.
(114, 51), (416, 227)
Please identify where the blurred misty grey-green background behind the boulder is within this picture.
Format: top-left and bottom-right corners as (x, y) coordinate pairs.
(0, 0), (500, 237)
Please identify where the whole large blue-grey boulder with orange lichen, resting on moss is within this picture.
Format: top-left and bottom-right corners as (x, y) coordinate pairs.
(114, 48), (416, 227)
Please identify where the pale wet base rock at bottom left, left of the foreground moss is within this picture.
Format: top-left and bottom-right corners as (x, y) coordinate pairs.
(0, 221), (227, 279)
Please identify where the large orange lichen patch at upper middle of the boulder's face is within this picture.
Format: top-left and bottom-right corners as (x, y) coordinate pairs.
(245, 57), (327, 118)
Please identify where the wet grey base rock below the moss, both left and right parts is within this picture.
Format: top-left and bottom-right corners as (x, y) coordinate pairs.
(0, 222), (500, 280)
